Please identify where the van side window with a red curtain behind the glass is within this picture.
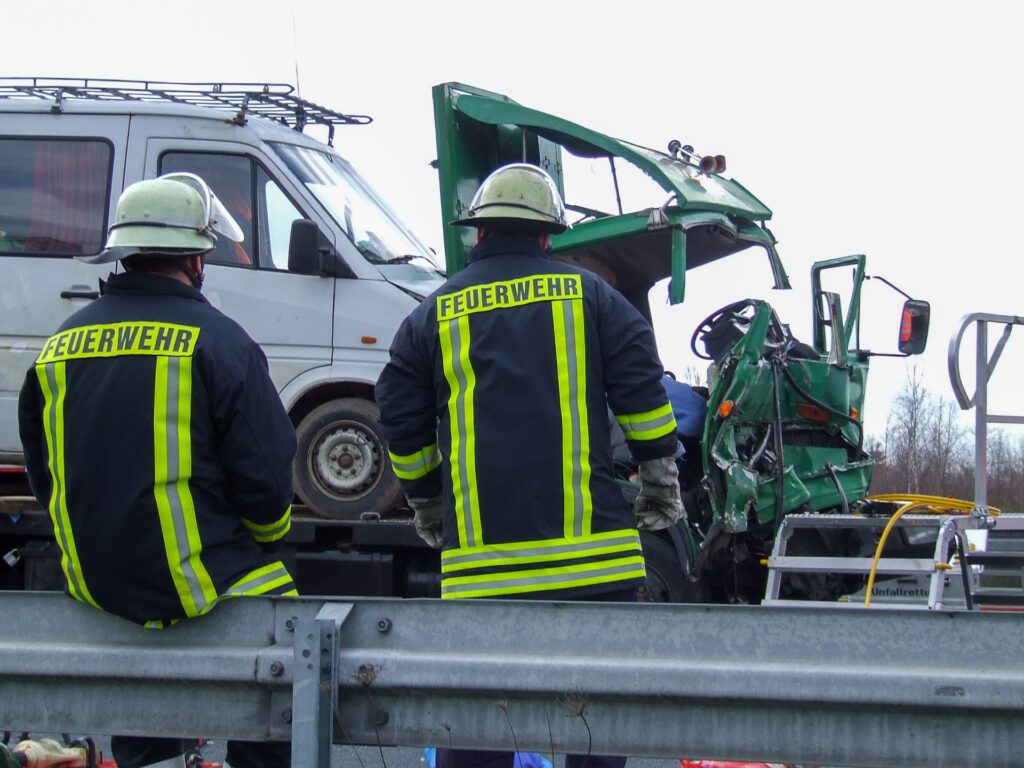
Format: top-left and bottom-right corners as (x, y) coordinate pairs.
(0, 138), (112, 256)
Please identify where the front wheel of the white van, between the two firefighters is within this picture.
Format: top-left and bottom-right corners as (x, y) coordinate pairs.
(292, 397), (404, 520)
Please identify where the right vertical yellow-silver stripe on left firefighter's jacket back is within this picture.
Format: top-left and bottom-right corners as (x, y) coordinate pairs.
(153, 356), (217, 616)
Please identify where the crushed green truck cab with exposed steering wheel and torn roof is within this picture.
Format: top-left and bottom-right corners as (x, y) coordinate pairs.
(433, 83), (929, 602)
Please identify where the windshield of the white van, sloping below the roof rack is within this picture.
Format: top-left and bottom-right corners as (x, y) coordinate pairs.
(272, 142), (441, 270)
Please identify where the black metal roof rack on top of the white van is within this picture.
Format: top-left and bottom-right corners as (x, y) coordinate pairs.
(0, 77), (373, 144)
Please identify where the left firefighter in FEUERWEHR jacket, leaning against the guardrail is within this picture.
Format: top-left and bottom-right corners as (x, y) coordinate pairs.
(18, 174), (296, 768)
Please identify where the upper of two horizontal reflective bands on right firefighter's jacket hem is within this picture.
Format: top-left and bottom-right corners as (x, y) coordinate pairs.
(441, 528), (643, 573)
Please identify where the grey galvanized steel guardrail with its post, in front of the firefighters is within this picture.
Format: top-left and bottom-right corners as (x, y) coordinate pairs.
(0, 593), (1024, 768)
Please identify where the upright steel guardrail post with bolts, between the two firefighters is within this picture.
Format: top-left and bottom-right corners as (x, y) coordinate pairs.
(292, 603), (352, 768)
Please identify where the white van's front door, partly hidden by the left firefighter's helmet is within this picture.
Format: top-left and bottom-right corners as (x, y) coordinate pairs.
(145, 138), (334, 397)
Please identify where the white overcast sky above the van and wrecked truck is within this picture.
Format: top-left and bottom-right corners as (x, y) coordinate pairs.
(0, 0), (1024, 434)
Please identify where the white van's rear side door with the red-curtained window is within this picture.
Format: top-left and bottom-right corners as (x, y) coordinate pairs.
(0, 112), (128, 464)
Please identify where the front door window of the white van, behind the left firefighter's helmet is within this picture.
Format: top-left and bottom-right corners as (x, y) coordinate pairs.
(160, 152), (302, 269)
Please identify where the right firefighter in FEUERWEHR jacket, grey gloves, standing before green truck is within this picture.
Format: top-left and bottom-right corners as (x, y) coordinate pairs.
(376, 164), (682, 768)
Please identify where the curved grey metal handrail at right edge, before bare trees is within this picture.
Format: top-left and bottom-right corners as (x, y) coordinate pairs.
(948, 312), (1024, 507)
